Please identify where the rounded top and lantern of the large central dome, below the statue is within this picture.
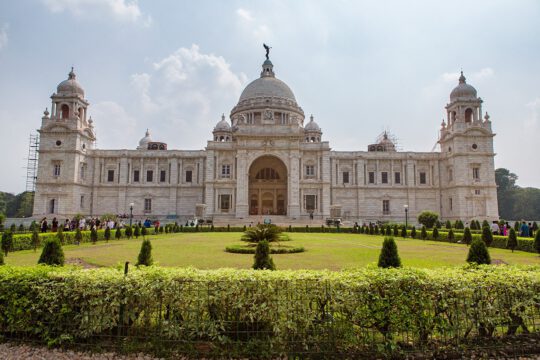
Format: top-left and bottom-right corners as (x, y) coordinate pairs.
(239, 60), (296, 102)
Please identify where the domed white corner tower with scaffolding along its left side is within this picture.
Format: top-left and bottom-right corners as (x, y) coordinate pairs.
(33, 68), (96, 217)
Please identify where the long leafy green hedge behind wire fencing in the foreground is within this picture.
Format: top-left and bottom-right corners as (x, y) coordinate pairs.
(0, 266), (540, 357)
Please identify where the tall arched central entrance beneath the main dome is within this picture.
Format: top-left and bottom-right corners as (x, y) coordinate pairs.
(249, 155), (287, 215)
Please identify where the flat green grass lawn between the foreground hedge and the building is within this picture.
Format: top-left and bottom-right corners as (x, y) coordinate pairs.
(5, 233), (540, 270)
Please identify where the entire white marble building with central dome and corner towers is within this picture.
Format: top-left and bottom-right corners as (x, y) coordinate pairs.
(34, 60), (498, 223)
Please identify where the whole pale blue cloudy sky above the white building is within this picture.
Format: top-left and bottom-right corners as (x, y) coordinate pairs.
(0, 0), (540, 193)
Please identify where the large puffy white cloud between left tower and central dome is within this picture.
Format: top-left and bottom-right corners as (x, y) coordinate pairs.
(131, 45), (246, 149)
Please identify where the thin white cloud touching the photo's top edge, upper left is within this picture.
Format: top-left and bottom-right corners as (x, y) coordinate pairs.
(42, 0), (152, 26)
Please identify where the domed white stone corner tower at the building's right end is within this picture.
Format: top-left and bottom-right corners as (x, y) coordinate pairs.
(439, 72), (499, 221)
